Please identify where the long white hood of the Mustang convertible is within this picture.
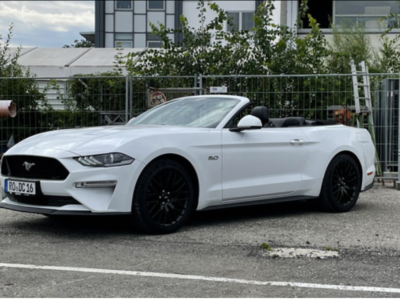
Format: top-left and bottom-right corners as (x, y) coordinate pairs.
(7, 125), (209, 155)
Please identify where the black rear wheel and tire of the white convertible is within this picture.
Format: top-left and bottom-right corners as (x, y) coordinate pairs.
(319, 154), (361, 212)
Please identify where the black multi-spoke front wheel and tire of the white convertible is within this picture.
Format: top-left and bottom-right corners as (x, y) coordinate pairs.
(132, 159), (196, 234)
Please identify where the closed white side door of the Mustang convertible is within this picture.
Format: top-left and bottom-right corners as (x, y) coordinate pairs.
(222, 127), (307, 202)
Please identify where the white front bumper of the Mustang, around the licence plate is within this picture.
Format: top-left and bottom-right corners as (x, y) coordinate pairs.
(0, 154), (144, 215)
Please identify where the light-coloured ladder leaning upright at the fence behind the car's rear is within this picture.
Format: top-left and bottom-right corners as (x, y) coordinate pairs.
(350, 60), (382, 175)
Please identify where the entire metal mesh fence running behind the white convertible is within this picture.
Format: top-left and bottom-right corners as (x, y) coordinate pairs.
(0, 74), (400, 176)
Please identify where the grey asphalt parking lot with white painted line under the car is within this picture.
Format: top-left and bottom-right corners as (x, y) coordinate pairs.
(0, 183), (400, 298)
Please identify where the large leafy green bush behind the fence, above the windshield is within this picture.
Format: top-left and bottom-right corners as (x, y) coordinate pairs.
(127, 1), (330, 116)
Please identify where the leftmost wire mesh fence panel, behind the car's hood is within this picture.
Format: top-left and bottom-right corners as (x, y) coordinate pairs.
(0, 77), (129, 148)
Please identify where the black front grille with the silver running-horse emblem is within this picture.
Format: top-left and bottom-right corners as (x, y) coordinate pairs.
(1, 155), (69, 180)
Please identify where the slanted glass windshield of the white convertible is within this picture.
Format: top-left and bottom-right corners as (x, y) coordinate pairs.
(127, 97), (240, 128)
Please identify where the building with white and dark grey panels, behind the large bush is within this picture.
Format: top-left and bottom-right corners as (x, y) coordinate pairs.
(95, 0), (268, 48)
